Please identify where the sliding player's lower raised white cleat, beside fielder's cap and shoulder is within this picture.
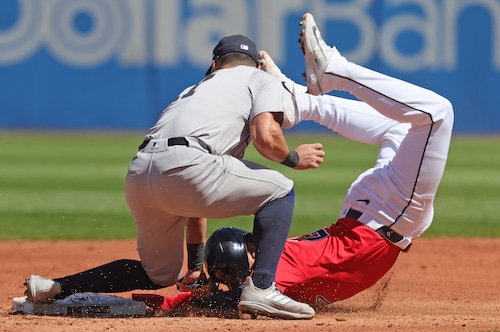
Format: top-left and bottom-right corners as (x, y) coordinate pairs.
(259, 51), (298, 129)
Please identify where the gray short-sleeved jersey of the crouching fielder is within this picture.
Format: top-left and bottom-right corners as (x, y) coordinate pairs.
(146, 66), (283, 158)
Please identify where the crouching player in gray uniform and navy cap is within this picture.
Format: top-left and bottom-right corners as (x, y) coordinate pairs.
(26, 35), (324, 319)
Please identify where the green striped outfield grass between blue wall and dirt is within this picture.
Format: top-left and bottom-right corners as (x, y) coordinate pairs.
(0, 132), (500, 240)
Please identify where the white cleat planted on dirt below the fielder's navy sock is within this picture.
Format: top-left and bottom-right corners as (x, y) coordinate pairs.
(238, 277), (315, 319)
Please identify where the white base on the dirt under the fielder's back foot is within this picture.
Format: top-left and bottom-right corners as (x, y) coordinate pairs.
(12, 293), (146, 317)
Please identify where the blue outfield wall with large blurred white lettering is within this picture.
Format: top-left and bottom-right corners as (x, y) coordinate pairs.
(0, 0), (500, 133)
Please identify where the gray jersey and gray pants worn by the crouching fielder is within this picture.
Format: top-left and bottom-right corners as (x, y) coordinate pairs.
(125, 66), (293, 286)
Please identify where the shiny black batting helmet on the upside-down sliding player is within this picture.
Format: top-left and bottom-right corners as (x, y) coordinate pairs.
(205, 227), (252, 289)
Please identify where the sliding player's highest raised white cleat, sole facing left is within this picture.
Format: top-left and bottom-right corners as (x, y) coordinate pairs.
(299, 13), (333, 96)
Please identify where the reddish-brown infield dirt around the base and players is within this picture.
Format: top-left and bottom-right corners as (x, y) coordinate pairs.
(0, 239), (500, 332)
